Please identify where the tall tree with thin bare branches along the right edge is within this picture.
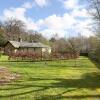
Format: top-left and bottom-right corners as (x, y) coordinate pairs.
(89, 0), (100, 61)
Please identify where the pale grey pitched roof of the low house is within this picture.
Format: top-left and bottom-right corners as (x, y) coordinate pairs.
(8, 41), (49, 48)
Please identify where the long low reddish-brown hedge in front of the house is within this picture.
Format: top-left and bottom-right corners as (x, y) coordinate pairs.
(9, 51), (79, 60)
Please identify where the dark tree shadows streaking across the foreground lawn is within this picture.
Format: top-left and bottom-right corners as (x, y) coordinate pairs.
(0, 72), (100, 100)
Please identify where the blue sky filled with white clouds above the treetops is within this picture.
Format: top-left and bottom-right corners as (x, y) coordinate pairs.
(0, 0), (92, 37)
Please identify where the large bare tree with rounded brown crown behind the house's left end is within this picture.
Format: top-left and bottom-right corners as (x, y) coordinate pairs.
(4, 18), (25, 40)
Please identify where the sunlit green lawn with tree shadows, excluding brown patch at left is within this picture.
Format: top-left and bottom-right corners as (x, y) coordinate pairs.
(0, 56), (100, 100)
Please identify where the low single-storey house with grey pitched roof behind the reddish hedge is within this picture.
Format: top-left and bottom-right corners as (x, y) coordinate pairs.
(4, 41), (51, 55)
